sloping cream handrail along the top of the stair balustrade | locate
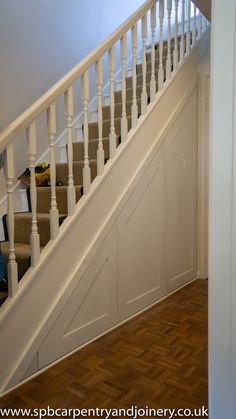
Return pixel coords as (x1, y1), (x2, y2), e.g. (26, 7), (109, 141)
(0, 0), (158, 151)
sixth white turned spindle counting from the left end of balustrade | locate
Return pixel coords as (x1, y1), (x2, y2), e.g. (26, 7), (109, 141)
(96, 58), (104, 175)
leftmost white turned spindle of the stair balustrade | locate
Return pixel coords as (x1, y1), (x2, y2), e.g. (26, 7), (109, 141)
(6, 143), (18, 297)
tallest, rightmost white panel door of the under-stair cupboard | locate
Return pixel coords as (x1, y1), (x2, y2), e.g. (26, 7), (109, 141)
(165, 90), (197, 292)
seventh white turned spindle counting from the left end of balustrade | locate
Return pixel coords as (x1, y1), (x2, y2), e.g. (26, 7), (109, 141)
(109, 45), (116, 158)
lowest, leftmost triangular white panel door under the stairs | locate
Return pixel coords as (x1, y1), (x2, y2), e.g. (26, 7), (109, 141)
(39, 228), (118, 368)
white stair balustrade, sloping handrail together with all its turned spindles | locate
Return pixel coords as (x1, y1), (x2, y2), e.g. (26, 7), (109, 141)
(0, 0), (207, 304)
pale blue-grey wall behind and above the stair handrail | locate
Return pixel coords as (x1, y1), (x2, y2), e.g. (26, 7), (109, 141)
(0, 0), (144, 202)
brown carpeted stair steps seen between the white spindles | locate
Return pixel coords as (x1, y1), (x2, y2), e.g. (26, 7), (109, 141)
(1, 42), (171, 301)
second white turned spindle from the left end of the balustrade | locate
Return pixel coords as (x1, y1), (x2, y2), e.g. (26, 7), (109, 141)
(27, 122), (40, 266)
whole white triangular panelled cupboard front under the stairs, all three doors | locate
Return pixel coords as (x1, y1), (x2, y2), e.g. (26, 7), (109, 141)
(39, 89), (197, 368)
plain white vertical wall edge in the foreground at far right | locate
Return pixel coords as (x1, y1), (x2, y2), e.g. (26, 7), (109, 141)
(209, 0), (236, 419)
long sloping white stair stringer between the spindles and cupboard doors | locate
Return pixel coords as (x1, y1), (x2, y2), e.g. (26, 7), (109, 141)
(0, 30), (210, 394)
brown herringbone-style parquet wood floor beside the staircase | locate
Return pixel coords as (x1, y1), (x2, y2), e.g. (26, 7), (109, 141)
(0, 280), (208, 416)
